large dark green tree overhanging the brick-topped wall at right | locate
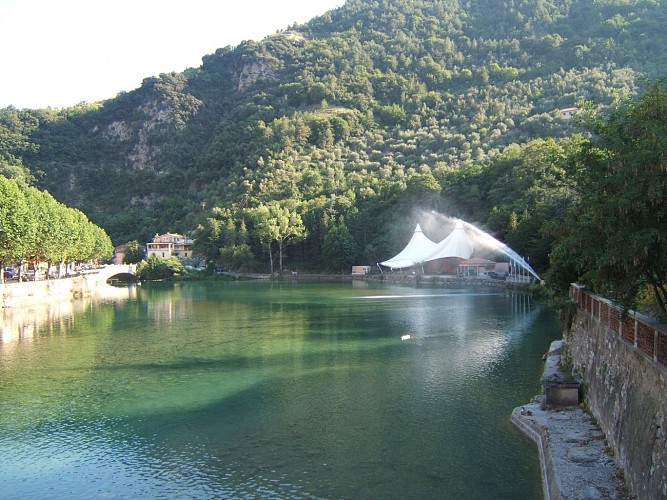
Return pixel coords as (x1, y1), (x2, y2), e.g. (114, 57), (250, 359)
(552, 83), (667, 315)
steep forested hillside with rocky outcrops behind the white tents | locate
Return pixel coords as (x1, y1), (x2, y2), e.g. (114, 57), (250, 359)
(0, 0), (667, 278)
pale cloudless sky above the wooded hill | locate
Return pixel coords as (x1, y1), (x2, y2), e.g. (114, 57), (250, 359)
(0, 0), (344, 108)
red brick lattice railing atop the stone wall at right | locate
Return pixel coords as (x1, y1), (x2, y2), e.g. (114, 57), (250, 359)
(570, 284), (667, 368)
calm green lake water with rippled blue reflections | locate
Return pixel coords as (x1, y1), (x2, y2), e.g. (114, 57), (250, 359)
(0, 281), (560, 499)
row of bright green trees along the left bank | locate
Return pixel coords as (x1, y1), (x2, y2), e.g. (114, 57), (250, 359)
(0, 176), (113, 279)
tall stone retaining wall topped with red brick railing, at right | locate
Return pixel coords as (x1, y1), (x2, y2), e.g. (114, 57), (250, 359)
(565, 286), (667, 499)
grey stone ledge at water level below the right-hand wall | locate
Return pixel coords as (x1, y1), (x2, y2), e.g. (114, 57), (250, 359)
(511, 341), (634, 500)
